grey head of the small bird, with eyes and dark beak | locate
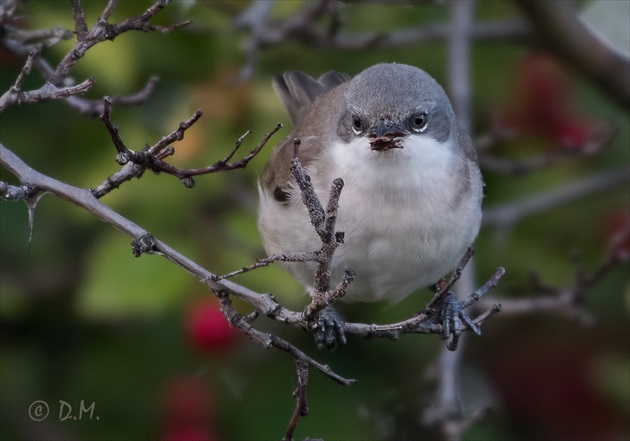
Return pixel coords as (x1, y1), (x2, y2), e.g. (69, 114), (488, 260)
(338, 64), (457, 151)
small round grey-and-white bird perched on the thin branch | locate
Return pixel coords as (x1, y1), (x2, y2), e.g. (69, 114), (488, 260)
(258, 63), (484, 345)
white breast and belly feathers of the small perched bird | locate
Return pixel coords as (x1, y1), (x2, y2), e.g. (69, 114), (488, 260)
(259, 136), (481, 301)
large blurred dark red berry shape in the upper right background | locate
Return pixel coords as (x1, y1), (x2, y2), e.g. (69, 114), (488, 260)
(497, 53), (597, 149)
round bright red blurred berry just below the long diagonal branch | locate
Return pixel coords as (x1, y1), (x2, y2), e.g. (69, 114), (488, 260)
(186, 298), (235, 353)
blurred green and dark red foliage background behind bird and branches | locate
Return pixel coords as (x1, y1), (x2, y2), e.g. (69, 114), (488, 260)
(0, 0), (630, 441)
